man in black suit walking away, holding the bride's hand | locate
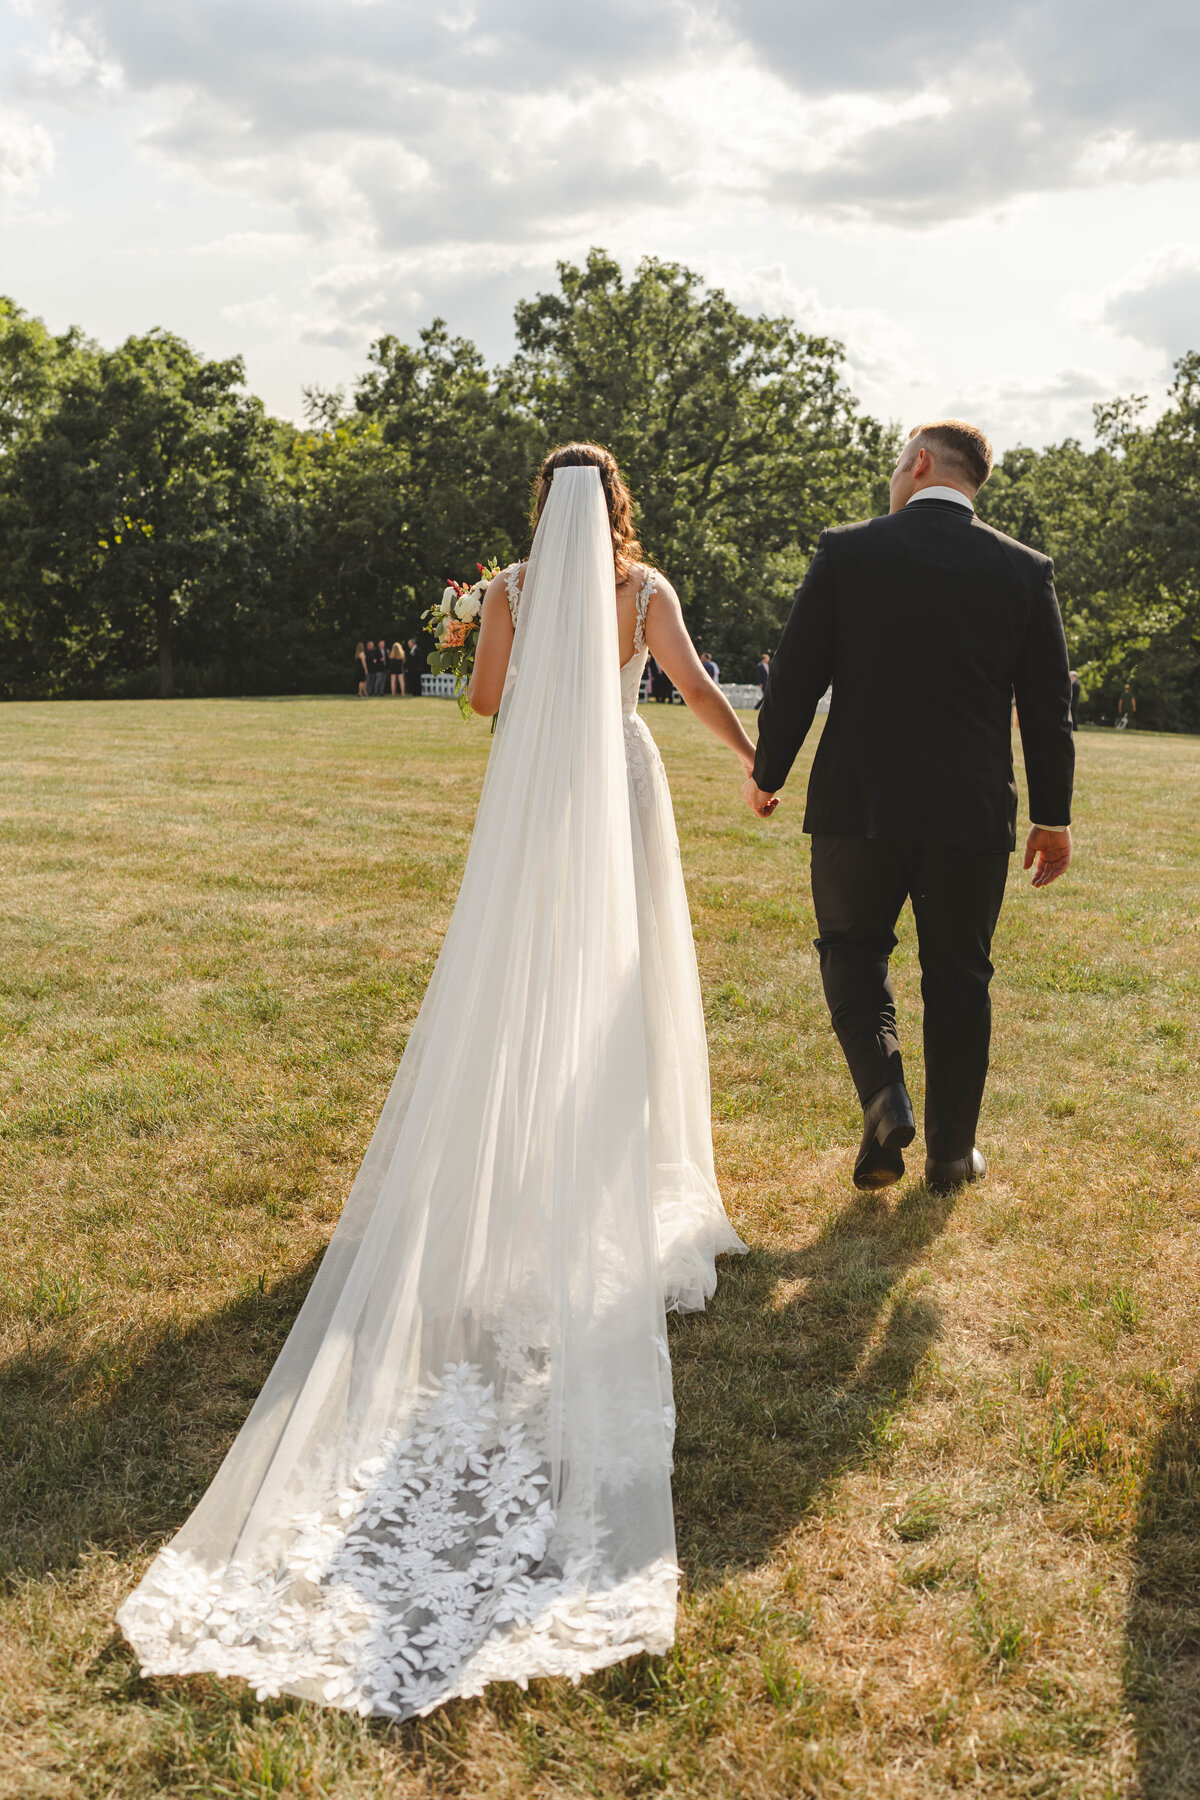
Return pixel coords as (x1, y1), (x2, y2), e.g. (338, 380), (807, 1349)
(745, 419), (1074, 1192)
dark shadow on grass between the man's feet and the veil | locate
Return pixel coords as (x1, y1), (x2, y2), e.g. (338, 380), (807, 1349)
(671, 1186), (954, 1586)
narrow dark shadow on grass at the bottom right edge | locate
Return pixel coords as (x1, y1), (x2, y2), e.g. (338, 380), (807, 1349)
(1124, 1382), (1200, 1800)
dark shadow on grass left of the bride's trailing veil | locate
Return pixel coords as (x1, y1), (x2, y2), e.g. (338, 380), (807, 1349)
(0, 1256), (320, 1580)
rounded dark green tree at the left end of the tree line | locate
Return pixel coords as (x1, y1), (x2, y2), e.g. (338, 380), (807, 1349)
(0, 331), (279, 695)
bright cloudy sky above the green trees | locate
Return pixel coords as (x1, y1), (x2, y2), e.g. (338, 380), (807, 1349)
(0, 0), (1200, 445)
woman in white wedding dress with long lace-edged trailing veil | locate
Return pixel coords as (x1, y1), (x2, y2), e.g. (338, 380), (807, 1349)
(117, 445), (754, 1719)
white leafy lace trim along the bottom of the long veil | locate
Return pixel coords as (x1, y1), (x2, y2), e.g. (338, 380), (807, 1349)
(119, 1346), (676, 1719)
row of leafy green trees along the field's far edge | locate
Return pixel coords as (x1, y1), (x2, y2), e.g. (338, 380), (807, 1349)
(0, 250), (1200, 729)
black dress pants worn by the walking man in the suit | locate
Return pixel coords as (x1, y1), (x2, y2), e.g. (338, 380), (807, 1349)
(811, 835), (1009, 1161)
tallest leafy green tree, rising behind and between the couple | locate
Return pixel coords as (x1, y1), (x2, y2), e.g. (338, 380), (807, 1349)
(506, 250), (891, 671)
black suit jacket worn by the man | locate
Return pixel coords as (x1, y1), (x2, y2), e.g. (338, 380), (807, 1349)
(754, 500), (1074, 850)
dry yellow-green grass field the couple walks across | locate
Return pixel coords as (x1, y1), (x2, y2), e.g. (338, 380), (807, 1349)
(0, 700), (1200, 1800)
